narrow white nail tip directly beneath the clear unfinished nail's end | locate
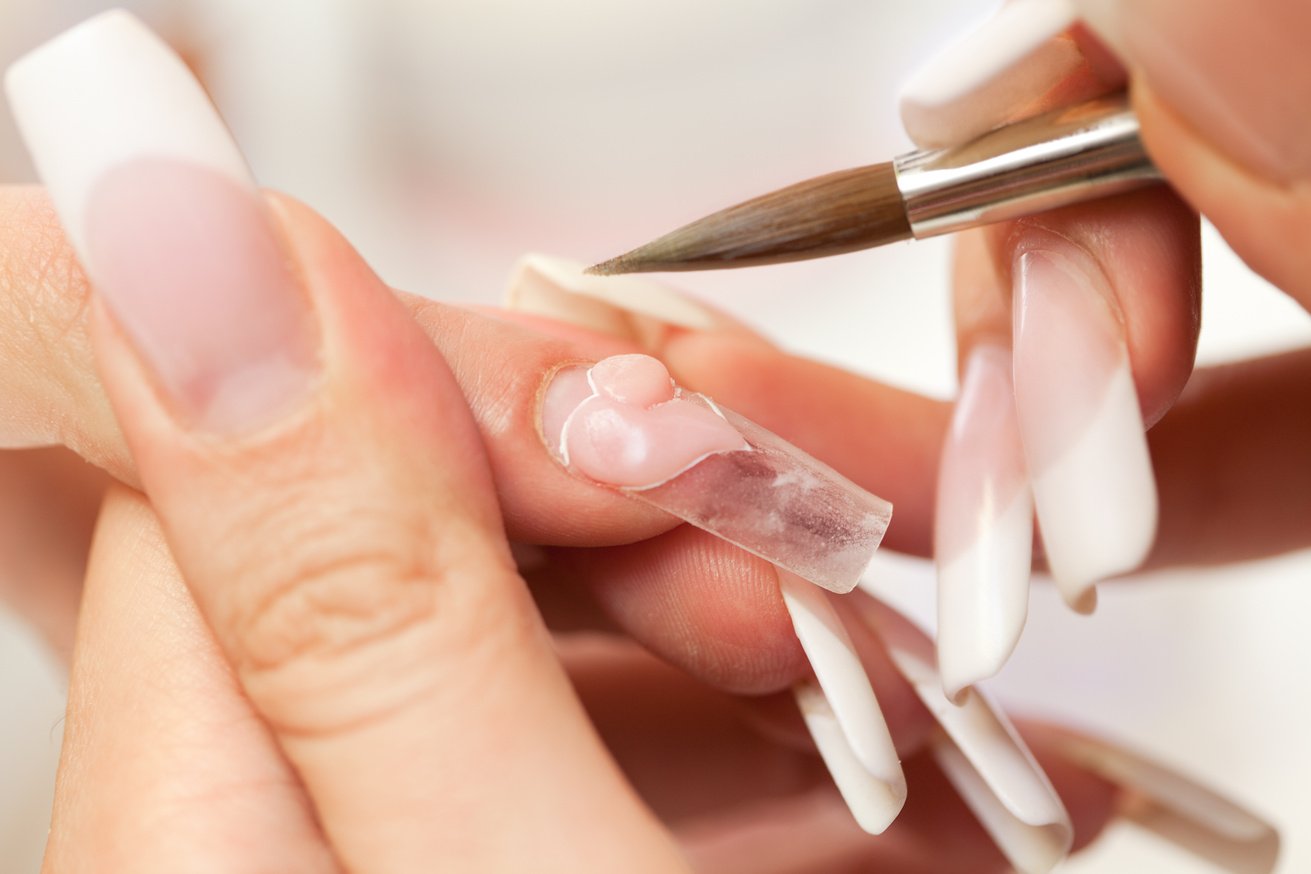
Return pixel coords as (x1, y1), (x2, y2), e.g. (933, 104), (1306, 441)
(777, 569), (905, 785)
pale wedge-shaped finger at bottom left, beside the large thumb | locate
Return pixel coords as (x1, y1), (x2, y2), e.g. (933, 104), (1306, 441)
(43, 487), (338, 874)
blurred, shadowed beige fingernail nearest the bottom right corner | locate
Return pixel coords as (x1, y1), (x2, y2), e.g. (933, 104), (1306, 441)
(1054, 731), (1280, 874)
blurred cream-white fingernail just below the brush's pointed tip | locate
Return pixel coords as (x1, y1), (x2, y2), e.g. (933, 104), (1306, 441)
(503, 254), (758, 349)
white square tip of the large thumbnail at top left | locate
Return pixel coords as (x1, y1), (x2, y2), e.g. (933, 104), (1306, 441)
(5, 9), (249, 259)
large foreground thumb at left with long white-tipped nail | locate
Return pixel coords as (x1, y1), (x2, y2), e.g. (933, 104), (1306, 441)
(9, 13), (679, 871)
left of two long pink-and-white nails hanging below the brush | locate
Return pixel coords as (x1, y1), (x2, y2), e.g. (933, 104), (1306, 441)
(933, 345), (1033, 700)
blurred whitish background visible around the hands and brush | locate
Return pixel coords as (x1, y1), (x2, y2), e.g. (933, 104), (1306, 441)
(0, 0), (1311, 874)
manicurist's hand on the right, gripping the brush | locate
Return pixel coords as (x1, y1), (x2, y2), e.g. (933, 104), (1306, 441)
(880, 0), (1311, 689)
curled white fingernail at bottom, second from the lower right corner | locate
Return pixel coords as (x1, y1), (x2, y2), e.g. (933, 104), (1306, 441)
(853, 596), (1074, 874)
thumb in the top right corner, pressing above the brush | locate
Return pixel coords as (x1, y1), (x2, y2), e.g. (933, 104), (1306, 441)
(1076, 0), (1311, 308)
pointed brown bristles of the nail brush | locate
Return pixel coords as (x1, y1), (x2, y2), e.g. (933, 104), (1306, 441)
(587, 164), (911, 275)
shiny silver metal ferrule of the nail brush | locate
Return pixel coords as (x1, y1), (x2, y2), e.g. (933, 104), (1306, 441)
(894, 94), (1162, 237)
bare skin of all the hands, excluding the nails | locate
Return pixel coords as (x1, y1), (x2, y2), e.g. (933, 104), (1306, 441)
(0, 4), (1311, 873)
